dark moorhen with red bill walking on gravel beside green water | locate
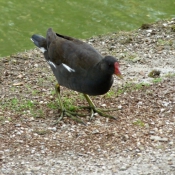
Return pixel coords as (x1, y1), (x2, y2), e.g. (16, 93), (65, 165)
(31, 28), (122, 123)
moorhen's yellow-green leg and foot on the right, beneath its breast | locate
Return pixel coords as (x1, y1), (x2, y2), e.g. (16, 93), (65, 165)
(83, 94), (116, 119)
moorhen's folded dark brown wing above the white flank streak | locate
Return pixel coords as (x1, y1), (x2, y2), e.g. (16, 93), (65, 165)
(46, 29), (103, 70)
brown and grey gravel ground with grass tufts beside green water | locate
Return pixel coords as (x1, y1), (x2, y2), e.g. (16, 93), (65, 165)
(0, 19), (175, 175)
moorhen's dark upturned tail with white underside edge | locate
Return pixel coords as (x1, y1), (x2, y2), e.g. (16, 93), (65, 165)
(31, 34), (47, 52)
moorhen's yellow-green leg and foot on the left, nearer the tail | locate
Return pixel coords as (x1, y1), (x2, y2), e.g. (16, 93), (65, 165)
(55, 84), (85, 125)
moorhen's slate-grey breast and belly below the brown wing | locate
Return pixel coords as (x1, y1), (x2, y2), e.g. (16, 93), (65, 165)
(52, 64), (113, 95)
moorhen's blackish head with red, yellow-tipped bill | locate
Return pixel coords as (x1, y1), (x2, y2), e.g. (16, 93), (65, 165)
(101, 56), (123, 79)
